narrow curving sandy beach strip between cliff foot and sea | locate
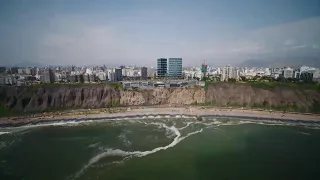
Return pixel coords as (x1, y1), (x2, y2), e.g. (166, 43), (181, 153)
(0, 106), (320, 128)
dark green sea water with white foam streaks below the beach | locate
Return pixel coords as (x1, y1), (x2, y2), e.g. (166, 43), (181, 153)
(0, 118), (320, 180)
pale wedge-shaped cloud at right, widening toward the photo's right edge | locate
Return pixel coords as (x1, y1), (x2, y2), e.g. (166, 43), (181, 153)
(203, 17), (320, 62)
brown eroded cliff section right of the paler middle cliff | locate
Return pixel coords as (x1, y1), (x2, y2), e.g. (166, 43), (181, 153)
(206, 83), (320, 110)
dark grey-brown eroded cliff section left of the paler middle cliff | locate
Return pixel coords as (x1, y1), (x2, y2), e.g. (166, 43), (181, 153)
(0, 85), (120, 112)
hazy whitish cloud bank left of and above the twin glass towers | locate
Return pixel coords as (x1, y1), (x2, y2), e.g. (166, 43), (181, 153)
(37, 16), (205, 65)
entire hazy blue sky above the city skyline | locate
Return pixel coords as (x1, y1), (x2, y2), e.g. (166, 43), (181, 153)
(0, 0), (320, 66)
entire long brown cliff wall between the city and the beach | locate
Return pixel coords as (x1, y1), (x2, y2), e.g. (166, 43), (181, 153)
(0, 83), (320, 114)
